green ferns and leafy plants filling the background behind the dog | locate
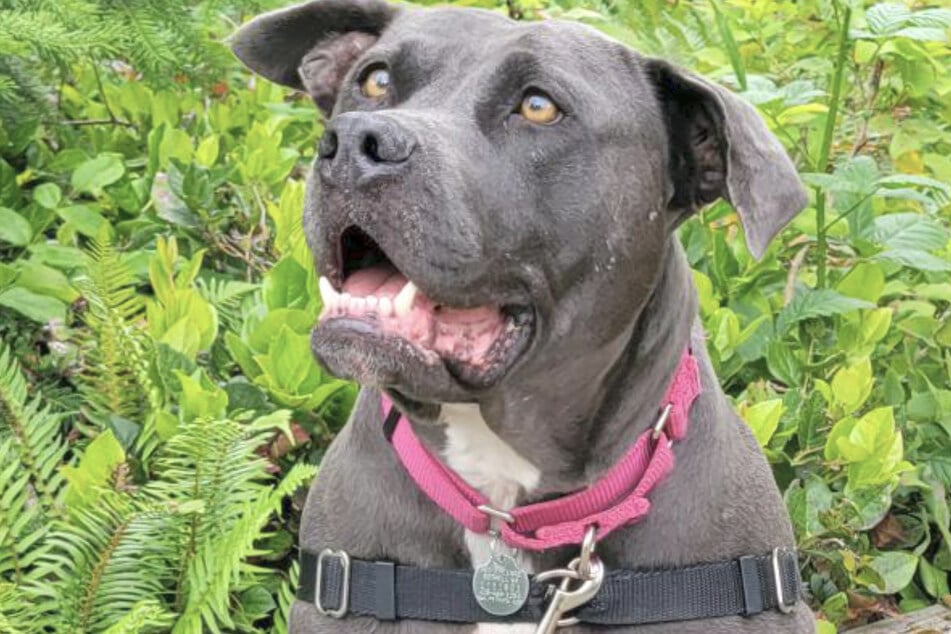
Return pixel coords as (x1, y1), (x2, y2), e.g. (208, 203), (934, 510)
(0, 0), (951, 633)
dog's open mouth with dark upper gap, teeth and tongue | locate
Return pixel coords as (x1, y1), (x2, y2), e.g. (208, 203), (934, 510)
(320, 226), (533, 387)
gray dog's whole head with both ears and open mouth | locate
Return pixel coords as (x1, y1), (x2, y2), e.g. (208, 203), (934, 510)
(233, 0), (805, 402)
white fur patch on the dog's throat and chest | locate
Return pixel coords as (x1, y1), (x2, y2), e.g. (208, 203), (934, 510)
(439, 403), (541, 634)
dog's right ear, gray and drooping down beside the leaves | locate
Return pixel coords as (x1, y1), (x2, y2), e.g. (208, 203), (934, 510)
(646, 60), (807, 258)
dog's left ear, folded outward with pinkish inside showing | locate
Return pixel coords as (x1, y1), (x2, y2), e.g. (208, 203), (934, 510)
(230, 0), (397, 114)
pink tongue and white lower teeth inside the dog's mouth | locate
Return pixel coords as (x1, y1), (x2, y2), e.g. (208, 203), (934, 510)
(320, 265), (506, 367)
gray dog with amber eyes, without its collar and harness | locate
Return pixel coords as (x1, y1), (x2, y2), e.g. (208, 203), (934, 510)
(232, 0), (815, 634)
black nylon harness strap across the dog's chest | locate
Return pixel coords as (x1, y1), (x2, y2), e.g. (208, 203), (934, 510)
(297, 549), (801, 625)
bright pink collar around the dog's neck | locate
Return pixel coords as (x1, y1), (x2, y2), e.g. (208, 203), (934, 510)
(383, 348), (701, 550)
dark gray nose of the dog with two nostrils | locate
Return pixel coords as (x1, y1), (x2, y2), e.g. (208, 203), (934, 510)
(317, 112), (416, 181)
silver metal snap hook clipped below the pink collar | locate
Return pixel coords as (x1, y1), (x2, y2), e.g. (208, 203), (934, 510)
(535, 526), (604, 634)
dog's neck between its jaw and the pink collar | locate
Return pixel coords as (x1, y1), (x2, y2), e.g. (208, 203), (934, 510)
(416, 238), (697, 506)
